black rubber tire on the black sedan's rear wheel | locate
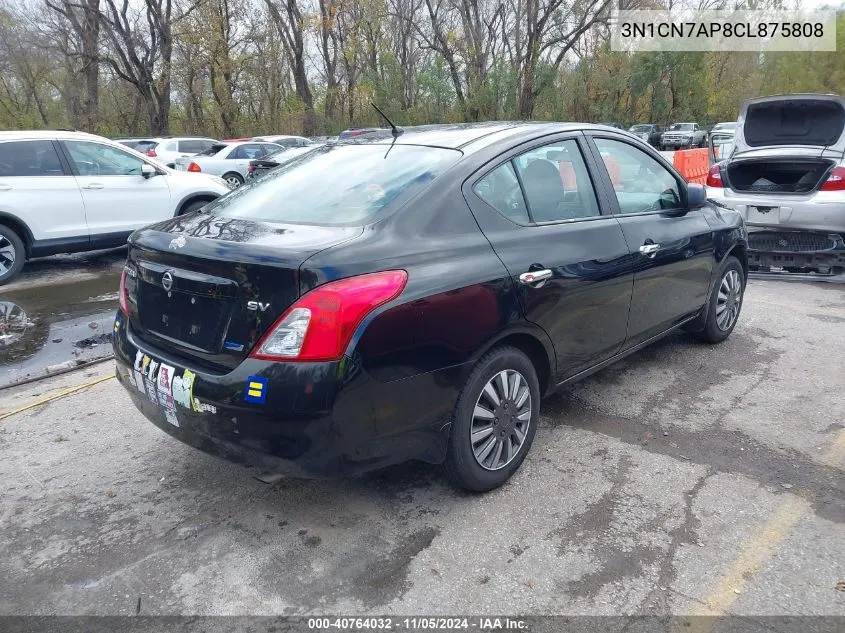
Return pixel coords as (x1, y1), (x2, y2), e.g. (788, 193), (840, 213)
(443, 346), (540, 492)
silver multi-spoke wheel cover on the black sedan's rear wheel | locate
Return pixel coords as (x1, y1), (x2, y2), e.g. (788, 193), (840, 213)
(470, 369), (531, 470)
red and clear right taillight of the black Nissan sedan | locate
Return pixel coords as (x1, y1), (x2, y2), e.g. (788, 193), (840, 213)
(250, 270), (408, 361)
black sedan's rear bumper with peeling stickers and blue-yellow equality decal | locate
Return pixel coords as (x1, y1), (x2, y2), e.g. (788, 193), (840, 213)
(114, 314), (460, 478)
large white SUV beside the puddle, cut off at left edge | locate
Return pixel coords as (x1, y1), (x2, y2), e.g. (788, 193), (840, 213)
(0, 131), (229, 285)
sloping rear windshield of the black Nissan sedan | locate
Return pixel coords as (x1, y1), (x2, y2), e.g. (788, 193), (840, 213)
(205, 144), (461, 225)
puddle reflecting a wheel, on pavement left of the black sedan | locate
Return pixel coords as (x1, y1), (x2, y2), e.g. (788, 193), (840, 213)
(0, 271), (120, 387)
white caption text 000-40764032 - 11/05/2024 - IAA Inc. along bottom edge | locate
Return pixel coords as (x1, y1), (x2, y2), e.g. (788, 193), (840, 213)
(308, 616), (528, 631)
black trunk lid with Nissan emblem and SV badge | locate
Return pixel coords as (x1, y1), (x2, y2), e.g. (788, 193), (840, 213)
(127, 214), (363, 371)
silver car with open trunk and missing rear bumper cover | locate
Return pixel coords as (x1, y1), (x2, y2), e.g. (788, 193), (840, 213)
(707, 94), (845, 275)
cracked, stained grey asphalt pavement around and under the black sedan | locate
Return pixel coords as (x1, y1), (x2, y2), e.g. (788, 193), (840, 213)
(0, 270), (845, 616)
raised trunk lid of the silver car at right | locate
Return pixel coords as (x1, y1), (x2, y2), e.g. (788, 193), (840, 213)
(734, 95), (845, 157)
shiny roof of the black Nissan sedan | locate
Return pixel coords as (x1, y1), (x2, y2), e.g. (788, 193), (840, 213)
(336, 121), (620, 153)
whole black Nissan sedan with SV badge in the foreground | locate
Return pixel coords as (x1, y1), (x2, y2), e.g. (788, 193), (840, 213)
(114, 123), (747, 491)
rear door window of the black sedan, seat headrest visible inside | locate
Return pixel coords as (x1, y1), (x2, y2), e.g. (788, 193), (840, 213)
(513, 140), (600, 222)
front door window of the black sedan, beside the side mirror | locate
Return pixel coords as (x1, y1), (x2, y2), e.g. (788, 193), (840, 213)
(595, 138), (682, 213)
